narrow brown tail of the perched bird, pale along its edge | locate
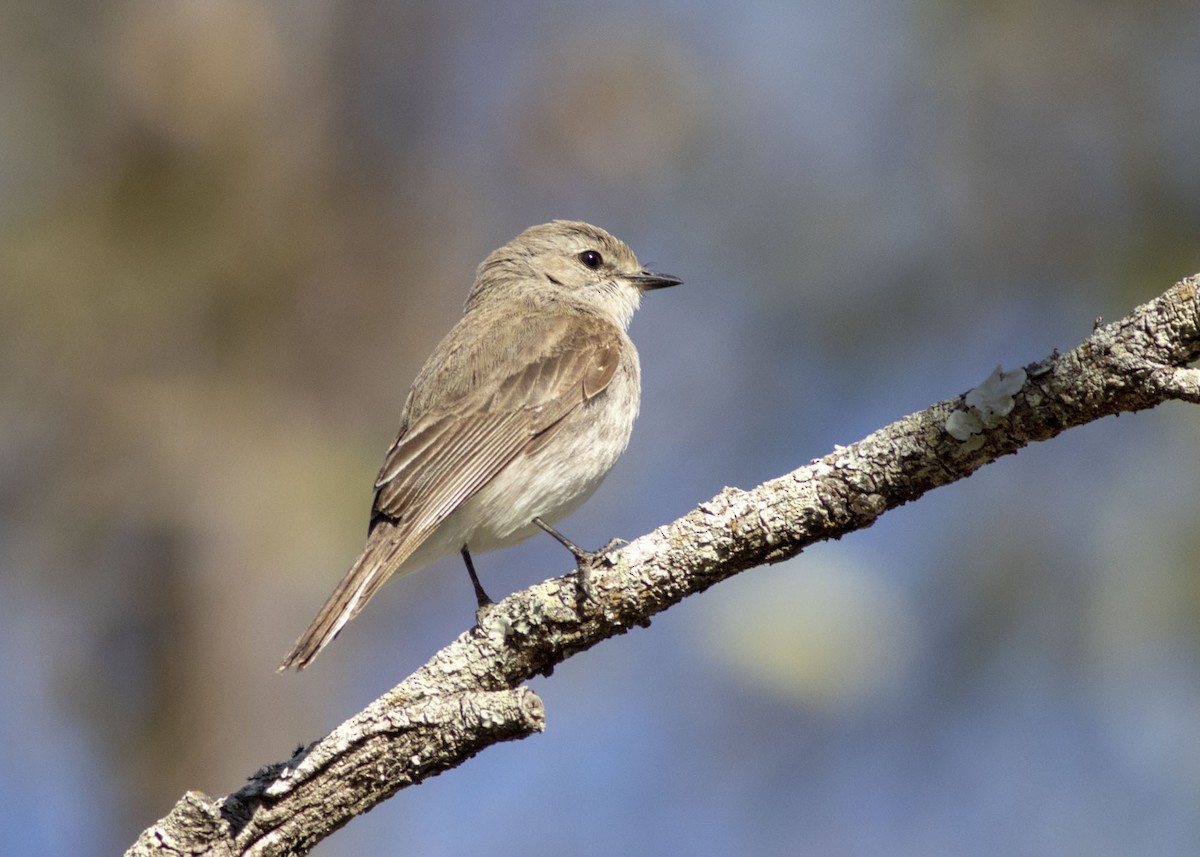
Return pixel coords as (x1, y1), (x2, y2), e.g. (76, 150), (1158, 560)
(278, 523), (416, 672)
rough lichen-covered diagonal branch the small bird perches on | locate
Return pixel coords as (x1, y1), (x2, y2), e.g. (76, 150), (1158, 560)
(126, 275), (1200, 857)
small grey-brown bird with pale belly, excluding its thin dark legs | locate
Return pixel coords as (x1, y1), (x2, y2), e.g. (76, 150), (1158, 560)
(280, 221), (679, 670)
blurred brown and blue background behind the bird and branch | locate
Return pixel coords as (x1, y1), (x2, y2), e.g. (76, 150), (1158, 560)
(0, 0), (1200, 857)
